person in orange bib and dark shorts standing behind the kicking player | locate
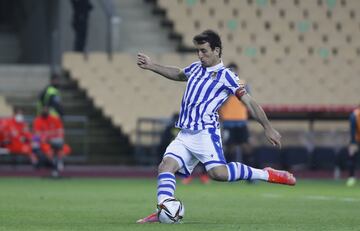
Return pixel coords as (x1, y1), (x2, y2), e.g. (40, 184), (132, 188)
(219, 63), (253, 172)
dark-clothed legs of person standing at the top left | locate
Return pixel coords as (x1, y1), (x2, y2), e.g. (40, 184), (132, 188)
(71, 0), (93, 52)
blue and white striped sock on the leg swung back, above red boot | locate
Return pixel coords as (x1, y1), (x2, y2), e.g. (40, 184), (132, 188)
(226, 162), (269, 181)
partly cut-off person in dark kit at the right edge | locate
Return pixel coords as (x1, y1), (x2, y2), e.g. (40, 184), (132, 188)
(346, 105), (360, 187)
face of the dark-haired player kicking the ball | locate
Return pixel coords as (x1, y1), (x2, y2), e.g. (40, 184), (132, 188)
(195, 43), (220, 67)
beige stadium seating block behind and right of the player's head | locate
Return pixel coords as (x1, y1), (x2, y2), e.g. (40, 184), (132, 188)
(158, 0), (360, 105)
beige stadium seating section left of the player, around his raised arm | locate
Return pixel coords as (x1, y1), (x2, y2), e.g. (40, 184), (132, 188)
(63, 53), (195, 141)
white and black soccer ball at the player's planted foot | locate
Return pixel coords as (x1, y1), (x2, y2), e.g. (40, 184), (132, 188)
(157, 198), (185, 224)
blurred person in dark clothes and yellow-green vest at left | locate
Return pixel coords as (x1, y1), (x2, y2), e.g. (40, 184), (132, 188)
(37, 74), (64, 118)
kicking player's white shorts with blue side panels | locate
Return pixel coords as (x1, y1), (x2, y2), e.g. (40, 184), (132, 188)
(164, 128), (226, 176)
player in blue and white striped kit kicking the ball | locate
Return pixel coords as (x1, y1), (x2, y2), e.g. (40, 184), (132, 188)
(137, 30), (296, 223)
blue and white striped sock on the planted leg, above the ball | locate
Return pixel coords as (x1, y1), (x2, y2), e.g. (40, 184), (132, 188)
(157, 172), (176, 204)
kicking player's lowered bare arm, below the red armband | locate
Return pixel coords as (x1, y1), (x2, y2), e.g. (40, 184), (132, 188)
(238, 93), (281, 148)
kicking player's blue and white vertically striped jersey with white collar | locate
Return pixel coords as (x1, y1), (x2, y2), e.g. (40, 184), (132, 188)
(175, 61), (245, 130)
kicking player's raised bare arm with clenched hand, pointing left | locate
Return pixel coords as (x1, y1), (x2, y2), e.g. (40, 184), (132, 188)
(137, 53), (187, 81)
